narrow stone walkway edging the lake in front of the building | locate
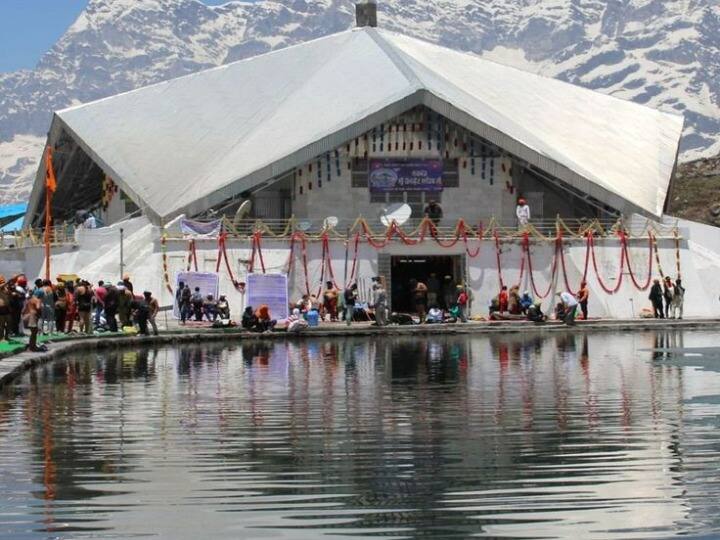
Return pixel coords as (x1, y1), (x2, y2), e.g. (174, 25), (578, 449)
(0, 319), (720, 386)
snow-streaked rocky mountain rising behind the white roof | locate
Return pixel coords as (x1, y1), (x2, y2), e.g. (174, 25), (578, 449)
(0, 0), (720, 202)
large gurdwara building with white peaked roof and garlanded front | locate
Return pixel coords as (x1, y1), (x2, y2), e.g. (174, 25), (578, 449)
(3, 3), (720, 317)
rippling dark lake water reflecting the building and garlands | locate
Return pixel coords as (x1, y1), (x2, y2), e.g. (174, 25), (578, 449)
(0, 332), (720, 538)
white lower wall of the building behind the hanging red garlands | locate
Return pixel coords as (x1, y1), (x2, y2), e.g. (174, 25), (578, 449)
(0, 222), (720, 318)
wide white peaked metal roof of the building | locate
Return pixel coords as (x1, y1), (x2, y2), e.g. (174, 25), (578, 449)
(28, 27), (683, 221)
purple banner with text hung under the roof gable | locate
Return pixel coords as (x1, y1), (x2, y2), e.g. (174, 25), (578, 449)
(368, 159), (443, 193)
